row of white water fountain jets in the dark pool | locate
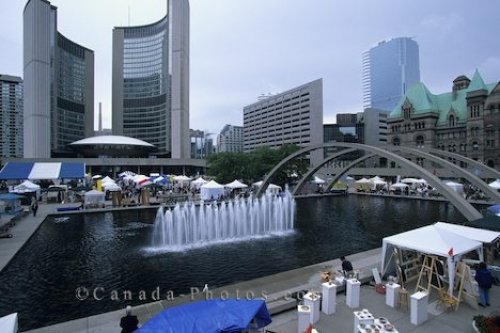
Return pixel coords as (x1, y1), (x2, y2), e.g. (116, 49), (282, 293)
(153, 190), (295, 250)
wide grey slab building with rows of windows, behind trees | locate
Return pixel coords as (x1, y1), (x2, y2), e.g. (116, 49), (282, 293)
(243, 79), (323, 164)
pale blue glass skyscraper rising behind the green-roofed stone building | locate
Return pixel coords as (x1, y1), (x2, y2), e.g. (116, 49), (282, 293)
(363, 37), (420, 111)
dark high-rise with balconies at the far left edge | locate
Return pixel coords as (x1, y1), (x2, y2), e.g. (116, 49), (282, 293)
(0, 74), (23, 157)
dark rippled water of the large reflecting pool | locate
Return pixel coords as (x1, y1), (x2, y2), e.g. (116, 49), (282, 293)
(0, 195), (465, 331)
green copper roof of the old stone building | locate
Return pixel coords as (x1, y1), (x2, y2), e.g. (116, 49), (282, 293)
(389, 70), (497, 126)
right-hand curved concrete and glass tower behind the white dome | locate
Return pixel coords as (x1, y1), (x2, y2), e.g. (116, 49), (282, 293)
(112, 0), (190, 158)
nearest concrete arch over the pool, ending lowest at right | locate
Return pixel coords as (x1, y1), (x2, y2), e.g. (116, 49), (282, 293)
(257, 142), (482, 221)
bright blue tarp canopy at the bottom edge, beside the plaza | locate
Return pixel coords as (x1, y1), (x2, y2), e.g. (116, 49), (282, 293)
(135, 299), (271, 333)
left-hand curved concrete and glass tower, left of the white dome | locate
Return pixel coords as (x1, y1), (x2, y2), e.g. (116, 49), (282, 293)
(23, 0), (94, 158)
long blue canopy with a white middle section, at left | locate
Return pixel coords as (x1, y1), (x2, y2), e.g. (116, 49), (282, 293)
(0, 162), (85, 180)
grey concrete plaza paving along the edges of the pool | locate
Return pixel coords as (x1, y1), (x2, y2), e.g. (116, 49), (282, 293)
(0, 204), (500, 333)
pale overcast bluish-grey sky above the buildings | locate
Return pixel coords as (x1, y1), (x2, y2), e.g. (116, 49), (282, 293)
(0, 0), (500, 133)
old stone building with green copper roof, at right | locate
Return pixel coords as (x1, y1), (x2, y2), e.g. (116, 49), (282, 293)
(387, 71), (500, 170)
